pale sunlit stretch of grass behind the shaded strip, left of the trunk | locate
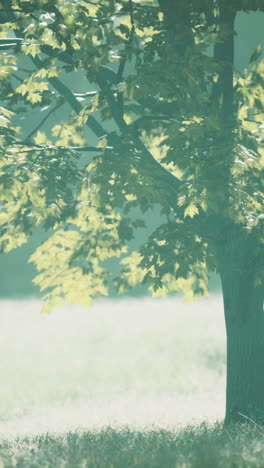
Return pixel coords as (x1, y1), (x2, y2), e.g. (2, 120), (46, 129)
(0, 296), (225, 436)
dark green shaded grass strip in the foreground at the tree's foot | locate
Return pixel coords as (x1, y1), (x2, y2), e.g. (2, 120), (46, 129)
(0, 424), (264, 468)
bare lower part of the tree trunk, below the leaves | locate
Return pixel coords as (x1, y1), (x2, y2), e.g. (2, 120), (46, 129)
(221, 241), (264, 423)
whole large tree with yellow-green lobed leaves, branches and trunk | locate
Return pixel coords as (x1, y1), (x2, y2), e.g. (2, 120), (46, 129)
(0, 0), (264, 422)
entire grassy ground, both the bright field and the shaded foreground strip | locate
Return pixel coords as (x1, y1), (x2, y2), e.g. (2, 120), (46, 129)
(0, 295), (264, 468)
